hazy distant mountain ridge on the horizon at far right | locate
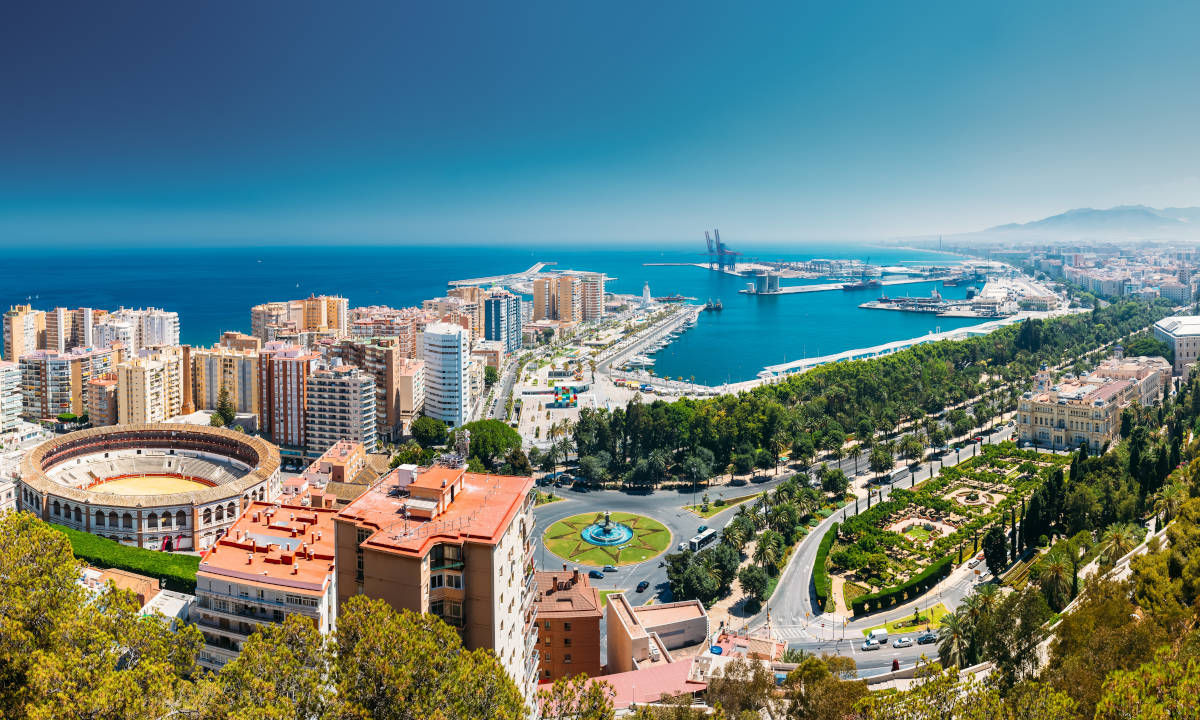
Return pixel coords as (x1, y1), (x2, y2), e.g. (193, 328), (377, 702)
(984, 205), (1200, 236)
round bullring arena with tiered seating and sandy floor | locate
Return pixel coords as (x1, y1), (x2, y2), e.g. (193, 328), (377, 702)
(18, 424), (280, 551)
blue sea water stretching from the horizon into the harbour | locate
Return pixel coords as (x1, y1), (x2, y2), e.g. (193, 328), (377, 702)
(0, 245), (977, 384)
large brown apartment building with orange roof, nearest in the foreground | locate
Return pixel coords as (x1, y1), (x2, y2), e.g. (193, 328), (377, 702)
(335, 463), (539, 697)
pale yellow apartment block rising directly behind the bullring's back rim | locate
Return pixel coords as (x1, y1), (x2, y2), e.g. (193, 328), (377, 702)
(116, 347), (184, 425)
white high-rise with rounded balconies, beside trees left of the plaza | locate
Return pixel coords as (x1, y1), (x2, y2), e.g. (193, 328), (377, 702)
(420, 323), (470, 427)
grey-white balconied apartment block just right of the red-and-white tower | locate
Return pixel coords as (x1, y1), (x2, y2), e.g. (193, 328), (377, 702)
(305, 365), (378, 457)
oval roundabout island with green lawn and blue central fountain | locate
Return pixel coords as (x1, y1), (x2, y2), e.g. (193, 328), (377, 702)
(542, 511), (671, 568)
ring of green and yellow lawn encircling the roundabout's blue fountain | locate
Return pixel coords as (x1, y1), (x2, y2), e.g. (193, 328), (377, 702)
(545, 512), (671, 568)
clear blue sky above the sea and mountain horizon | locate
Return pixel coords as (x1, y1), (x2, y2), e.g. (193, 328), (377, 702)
(0, 0), (1200, 247)
